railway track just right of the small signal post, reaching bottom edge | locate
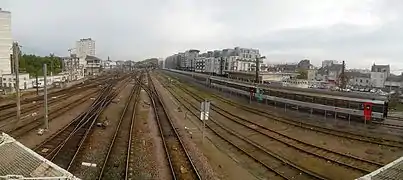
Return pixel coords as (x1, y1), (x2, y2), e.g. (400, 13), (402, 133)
(161, 75), (326, 179)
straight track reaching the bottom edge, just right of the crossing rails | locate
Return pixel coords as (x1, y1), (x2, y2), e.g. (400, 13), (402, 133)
(98, 75), (142, 179)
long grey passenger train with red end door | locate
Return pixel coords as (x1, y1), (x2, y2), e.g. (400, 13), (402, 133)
(166, 69), (388, 121)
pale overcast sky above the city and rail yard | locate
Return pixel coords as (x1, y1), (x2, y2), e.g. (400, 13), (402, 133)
(0, 0), (403, 72)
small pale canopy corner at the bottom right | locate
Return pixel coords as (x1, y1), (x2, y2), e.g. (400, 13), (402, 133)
(357, 157), (403, 180)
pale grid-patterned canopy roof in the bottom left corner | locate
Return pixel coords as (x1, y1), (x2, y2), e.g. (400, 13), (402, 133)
(0, 133), (79, 180)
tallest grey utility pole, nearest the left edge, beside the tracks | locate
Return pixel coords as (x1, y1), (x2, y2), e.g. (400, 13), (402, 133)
(13, 42), (21, 128)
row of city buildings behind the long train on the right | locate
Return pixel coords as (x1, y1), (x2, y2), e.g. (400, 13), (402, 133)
(163, 47), (403, 91)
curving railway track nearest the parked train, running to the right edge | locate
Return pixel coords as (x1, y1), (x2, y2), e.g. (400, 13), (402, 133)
(164, 74), (403, 148)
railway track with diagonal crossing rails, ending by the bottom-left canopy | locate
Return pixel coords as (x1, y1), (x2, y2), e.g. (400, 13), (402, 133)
(34, 82), (117, 170)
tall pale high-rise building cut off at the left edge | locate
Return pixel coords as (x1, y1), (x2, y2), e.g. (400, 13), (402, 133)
(0, 8), (13, 76)
